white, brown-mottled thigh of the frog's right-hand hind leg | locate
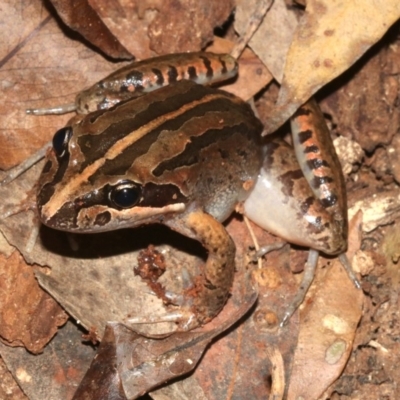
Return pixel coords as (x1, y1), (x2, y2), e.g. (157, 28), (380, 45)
(244, 150), (343, 254)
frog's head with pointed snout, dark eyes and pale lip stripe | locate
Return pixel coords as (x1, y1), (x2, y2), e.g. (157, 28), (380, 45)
(37, 119), (186, 233)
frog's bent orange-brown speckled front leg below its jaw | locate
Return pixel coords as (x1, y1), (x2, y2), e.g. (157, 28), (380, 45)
(165, 210), (236, 330)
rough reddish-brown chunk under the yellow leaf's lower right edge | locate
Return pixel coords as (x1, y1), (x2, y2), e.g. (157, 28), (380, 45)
(324, 39), (400, 153)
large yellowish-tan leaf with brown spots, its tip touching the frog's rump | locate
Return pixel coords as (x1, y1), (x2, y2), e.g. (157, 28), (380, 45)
(266, 0), (400, 132)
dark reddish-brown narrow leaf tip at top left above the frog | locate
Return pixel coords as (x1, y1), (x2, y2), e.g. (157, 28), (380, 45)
(51, 0), (133, 60)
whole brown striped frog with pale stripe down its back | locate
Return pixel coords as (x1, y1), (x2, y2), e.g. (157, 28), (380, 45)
(22, 53), (355, 329)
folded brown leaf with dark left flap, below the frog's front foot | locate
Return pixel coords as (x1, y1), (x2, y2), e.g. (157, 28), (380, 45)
(74, 292), (257, 399)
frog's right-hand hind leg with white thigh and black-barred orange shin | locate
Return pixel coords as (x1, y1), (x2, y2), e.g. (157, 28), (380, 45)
(244, 96), (360, 324)
